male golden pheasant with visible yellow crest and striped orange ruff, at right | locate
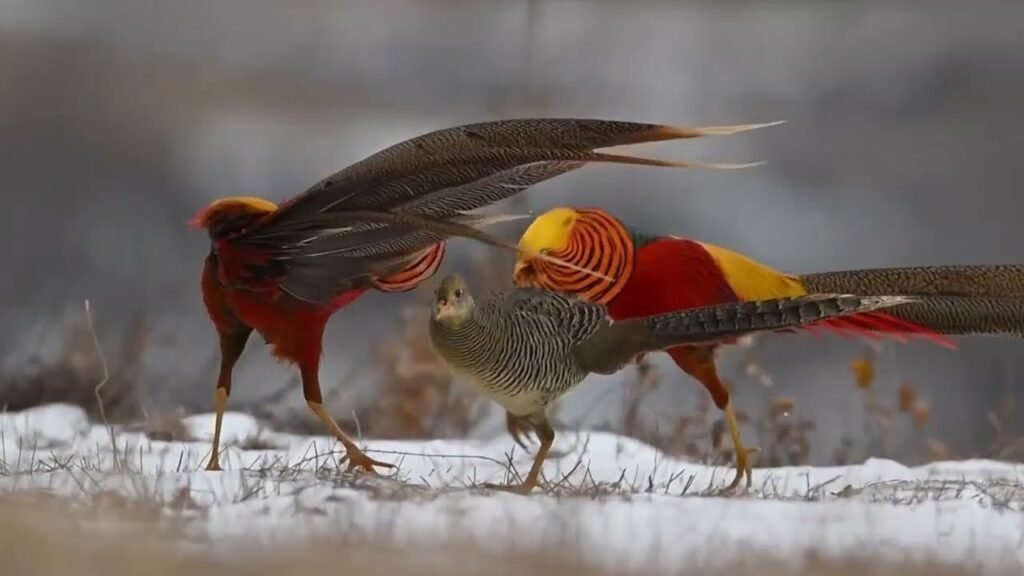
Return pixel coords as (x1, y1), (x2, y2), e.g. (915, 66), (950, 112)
(509, 207), (1024, 489)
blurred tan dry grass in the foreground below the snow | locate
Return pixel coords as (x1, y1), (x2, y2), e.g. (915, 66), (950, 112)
(0, 493), (1013, 576)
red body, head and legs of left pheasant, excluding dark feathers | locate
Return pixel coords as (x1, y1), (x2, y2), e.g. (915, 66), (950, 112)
(193, 198), (444, 470)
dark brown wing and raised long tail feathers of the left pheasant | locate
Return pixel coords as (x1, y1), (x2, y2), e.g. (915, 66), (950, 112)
(233, 119), (773, 300)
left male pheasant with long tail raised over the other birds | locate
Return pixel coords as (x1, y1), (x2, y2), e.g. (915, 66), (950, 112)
(191, 118), (769, 471)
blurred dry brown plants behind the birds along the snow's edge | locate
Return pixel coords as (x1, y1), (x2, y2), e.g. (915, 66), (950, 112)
(0, 252), (1024, 466)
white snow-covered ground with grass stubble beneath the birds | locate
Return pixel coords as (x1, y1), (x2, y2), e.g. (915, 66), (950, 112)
(0, 405), (1024, 570)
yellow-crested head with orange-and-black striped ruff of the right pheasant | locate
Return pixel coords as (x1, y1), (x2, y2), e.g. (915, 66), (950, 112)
(512, 207), (634, 303)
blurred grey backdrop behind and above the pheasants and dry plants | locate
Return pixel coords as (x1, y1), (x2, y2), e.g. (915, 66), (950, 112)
(0, 0), (1024, 458)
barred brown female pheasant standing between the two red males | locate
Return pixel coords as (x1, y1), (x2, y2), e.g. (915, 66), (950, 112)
(430, 274), (915, 493)
